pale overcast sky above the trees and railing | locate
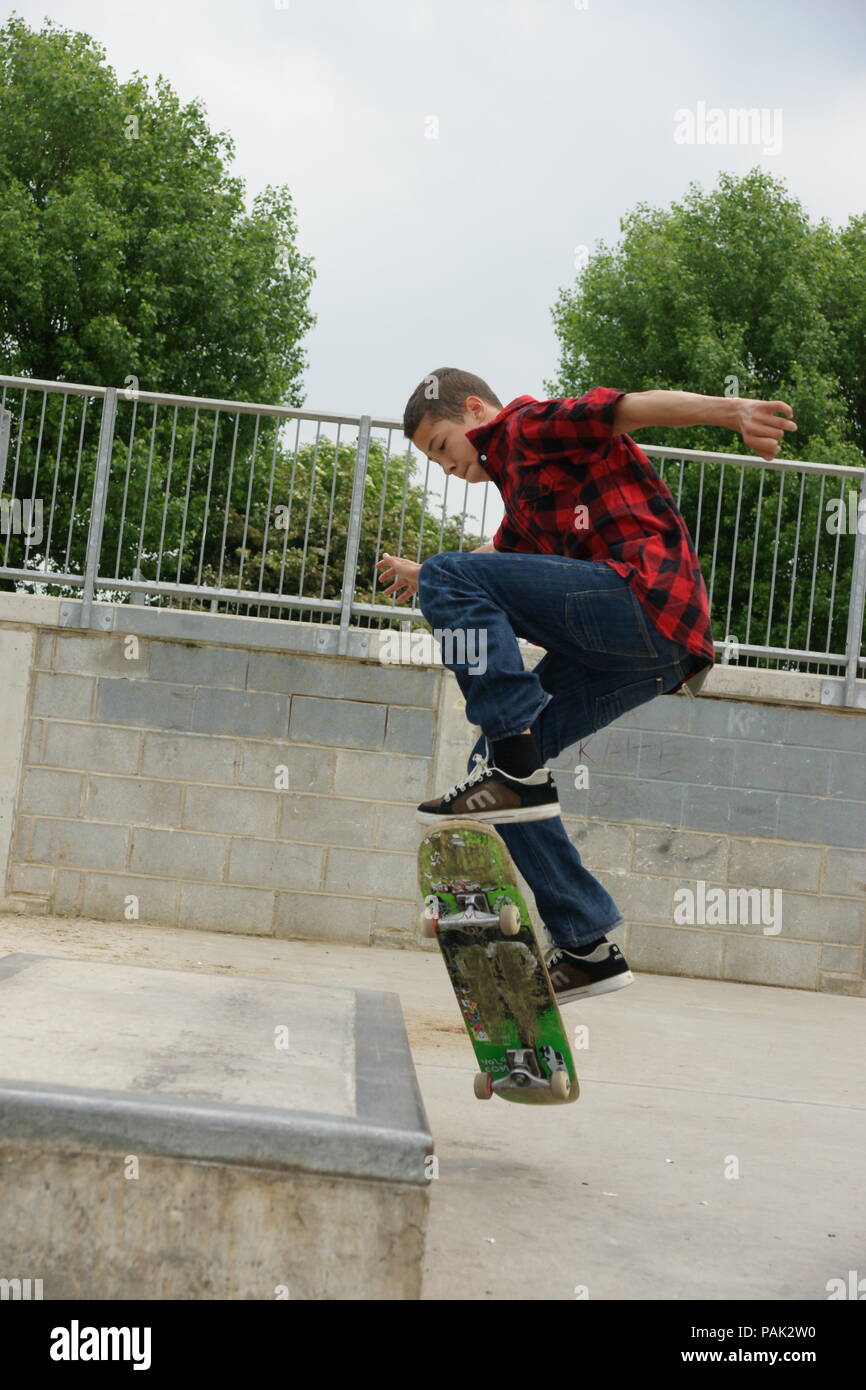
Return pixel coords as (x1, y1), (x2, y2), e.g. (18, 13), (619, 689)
(15, 0), (866, 417)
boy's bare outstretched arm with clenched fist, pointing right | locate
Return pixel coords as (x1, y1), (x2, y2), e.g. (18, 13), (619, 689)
(613, 391), (796, 461)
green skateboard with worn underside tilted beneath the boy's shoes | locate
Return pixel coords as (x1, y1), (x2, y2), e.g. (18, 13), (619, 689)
(418, 819), (580, 1105)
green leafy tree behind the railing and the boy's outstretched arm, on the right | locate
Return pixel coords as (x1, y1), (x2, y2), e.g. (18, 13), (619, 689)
(545, 170), (866, 667)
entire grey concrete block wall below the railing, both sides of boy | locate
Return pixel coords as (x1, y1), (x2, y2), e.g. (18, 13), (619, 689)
(0, 595), (866, 995)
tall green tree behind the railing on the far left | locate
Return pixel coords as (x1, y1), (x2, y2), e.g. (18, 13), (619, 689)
(0, 17), (314, 582)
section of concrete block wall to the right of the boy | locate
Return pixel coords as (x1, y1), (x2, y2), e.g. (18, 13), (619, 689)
(550, 695), (866, 995)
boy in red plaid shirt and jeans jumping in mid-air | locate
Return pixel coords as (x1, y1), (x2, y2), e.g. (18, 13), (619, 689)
(377, 367), (796, 1004)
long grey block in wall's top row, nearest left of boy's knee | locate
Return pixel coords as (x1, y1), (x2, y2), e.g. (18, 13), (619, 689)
(247, 652), (441, 709)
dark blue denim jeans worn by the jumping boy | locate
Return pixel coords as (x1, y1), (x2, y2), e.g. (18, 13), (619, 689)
(418, 552), (702, 947)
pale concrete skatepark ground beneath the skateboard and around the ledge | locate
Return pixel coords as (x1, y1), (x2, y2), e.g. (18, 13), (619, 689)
(0, 916), (866, 1300)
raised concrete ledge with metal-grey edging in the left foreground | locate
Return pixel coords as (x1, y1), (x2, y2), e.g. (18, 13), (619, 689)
(0, 954), (432, 1300)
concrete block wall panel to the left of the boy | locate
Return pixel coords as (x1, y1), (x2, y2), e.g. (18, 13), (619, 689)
(8, 630), (442, 942)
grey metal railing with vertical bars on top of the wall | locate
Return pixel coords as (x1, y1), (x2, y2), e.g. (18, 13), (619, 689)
(0, 377), (866, 705)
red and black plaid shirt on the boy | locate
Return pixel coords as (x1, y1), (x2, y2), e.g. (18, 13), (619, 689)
(466, 386), (716, 689)
